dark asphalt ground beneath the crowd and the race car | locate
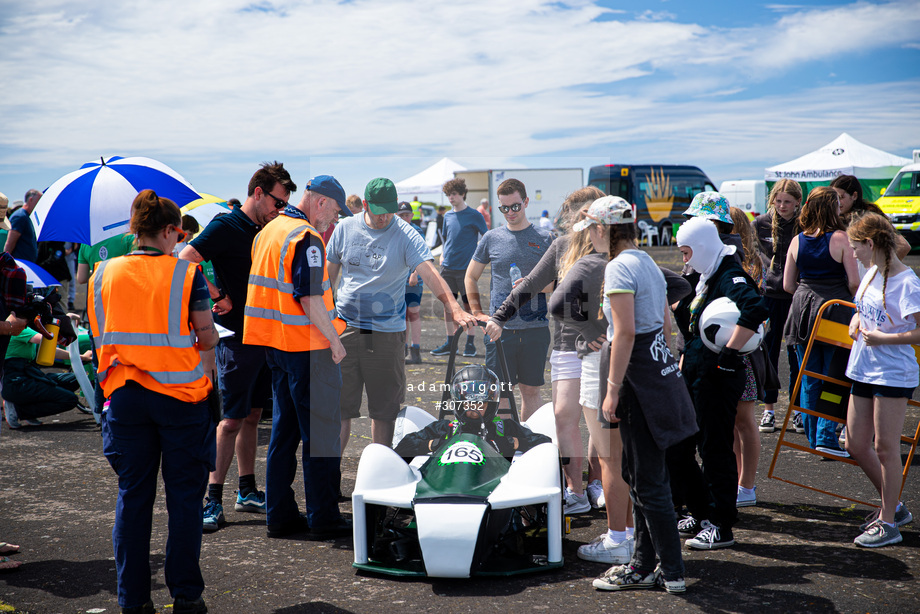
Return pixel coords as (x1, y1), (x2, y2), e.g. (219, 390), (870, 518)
(0, 247), (920, 614)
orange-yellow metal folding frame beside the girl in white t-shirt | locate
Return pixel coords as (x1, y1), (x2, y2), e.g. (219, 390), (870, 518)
(767, 300), (920, 507)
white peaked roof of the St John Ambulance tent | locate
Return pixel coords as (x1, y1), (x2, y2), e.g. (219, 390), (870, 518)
(764, 132), (910, 201)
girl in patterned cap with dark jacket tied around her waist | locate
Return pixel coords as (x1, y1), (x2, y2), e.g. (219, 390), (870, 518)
(589, 196), (697, 593)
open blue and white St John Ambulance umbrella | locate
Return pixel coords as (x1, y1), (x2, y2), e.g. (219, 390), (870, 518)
(30, 156), (201, 245)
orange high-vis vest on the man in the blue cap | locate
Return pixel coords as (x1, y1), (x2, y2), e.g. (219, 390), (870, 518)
(243, 215), (345, 352)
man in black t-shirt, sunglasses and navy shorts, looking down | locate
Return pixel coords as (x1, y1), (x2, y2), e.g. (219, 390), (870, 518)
(179, 162), (297, 532)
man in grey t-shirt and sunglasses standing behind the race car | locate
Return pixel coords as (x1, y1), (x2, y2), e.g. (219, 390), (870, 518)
(464, 179), (553, 420)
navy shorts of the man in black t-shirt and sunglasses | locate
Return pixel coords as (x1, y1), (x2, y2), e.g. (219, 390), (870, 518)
(214, 337), (272, 420)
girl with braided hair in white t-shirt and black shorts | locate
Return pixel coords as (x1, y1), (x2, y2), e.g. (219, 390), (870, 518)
(846, 213), (920, 548)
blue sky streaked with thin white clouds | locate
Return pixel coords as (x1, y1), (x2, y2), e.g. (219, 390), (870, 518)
(0, 0), (920, 207)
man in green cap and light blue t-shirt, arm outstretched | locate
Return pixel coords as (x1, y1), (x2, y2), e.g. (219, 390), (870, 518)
(326, 177), (476, 449)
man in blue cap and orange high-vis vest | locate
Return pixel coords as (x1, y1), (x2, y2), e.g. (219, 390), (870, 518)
(243, 175), (351, 539)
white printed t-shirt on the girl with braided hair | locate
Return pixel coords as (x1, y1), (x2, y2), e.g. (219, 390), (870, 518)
(846, 266), (920, 388)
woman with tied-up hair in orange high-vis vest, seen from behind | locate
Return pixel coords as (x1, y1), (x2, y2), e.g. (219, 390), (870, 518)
(87, 190), (217, 614)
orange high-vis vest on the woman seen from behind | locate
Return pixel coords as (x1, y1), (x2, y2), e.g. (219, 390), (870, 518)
(87, 255), (211, 403)
